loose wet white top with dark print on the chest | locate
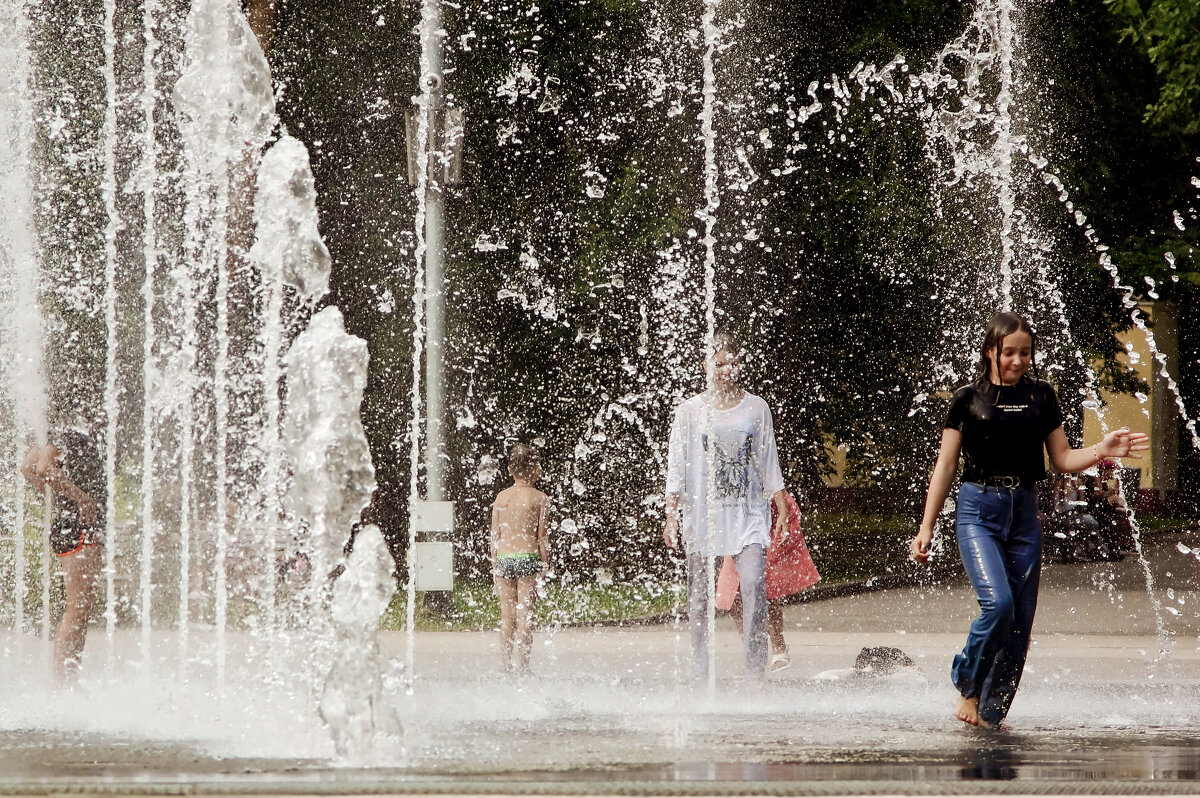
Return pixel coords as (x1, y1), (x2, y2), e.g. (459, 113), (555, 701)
(667, 394), (784, 556)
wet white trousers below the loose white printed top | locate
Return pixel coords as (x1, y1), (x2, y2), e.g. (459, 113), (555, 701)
(688, 544), (767, 679)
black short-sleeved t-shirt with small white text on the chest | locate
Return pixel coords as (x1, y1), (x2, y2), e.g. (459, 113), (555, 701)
(946, 377), (1062, 484)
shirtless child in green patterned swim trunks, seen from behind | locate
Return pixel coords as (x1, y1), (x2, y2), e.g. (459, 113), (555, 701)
(492, 444), (550, 673)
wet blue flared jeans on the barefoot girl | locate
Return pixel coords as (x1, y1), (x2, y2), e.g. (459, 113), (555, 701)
(950, 482), (1042, 724)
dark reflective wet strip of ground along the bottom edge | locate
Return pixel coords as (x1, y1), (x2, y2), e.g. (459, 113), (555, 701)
(7, 715), (1200, 794)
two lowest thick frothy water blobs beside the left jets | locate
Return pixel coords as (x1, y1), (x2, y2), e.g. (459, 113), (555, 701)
(283, 307), (376, 756)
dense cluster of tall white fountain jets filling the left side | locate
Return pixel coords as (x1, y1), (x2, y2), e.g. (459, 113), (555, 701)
(0, 0), (391, 758)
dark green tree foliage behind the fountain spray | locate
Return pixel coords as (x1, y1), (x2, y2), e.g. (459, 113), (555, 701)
(270, 0), (1200, 574)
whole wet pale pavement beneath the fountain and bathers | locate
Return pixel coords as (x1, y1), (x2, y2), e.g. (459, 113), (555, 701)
(7, 536), (1200, 794)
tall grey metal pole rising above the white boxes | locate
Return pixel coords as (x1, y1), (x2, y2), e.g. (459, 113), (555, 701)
(421, 0), (445, 502)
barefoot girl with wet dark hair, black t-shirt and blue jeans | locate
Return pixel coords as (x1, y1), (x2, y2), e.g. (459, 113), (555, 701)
(910, 312), (1148, 726)
